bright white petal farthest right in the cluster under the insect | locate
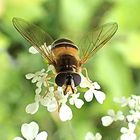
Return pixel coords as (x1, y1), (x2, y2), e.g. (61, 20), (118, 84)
(94, 90), (106, 104)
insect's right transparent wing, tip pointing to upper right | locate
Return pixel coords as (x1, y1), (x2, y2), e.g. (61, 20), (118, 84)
(79, 23), (118, 64)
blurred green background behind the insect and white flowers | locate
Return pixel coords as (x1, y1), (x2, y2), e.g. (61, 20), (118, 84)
(0, 0), (140, 140)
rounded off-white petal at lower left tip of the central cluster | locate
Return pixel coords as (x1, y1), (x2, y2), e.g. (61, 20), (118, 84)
(25, 102), (39, 114)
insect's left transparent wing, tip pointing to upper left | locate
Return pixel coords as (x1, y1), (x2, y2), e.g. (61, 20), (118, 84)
(12, 17), (55, 63)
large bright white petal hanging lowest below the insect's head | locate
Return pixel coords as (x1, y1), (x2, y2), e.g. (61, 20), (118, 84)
(59, 104), (72, 121)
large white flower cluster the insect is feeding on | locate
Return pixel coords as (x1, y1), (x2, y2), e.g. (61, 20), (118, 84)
(26, 65), (105, 121)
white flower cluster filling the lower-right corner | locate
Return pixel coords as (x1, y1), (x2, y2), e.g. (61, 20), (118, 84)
(101, 95), (140, 140)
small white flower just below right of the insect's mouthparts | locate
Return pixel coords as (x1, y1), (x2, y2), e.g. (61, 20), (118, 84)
(69, 93), (84, 108)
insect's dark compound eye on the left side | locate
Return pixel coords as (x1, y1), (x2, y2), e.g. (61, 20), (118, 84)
(55, 73), (67, 87)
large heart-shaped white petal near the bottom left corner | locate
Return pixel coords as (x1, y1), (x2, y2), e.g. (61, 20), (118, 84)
(21, 122), (39, 140)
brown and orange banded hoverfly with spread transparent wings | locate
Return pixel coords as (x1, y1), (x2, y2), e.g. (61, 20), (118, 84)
(12, 18), (118, 94)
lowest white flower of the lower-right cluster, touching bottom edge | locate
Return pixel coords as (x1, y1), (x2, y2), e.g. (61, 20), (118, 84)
(121, 123), (136, 140)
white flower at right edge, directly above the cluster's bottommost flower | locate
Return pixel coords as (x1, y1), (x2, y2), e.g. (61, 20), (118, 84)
(126, 110), (140, 122)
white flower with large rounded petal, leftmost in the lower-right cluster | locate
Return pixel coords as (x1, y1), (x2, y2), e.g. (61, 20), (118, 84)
(101, 109), (124, 126)
